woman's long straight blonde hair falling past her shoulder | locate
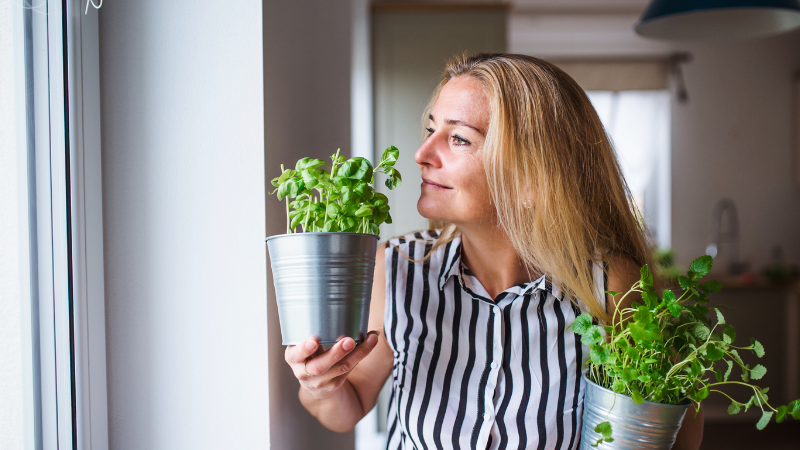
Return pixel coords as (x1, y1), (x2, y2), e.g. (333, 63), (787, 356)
(423, 54), (651, 322)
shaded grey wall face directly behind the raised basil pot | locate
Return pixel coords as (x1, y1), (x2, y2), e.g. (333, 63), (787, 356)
(264, 0), (354, 450)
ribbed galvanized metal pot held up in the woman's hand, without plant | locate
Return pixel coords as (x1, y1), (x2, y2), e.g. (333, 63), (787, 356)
(267, 233), (378, 345)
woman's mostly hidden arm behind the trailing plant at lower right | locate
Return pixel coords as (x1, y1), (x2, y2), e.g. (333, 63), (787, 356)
(606, 257), (704, 450)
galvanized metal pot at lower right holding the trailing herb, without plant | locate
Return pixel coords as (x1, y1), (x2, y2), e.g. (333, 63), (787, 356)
(581, 377), (690, 450)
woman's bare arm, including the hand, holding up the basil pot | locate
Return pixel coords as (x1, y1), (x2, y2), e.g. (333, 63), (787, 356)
(285, 246), (393, 432)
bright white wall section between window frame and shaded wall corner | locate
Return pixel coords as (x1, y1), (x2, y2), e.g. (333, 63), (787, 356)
(99, 0), (269, 450)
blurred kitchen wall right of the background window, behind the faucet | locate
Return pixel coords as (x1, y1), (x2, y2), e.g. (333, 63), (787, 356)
(672, 31), (800, 270)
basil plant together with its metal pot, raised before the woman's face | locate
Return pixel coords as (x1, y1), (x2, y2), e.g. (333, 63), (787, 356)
(267, 146), (401, 345)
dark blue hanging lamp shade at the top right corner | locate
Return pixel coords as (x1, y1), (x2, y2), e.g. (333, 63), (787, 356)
(634, 0), (800, 41)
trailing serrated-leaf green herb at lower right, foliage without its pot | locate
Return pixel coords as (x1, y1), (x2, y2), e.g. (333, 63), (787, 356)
(571, 256), (800, 447)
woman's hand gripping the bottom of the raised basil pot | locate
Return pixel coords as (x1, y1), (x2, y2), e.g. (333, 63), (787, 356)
(284, 330), (379, 399)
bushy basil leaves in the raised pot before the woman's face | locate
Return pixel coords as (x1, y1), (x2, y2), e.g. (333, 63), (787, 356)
(270, 146), (402, 234)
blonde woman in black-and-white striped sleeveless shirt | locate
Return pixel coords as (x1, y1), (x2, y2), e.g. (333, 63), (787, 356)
(286, 54), (702, 449)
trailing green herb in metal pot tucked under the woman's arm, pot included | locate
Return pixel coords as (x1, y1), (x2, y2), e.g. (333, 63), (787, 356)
(571, 256), (800, 449)
